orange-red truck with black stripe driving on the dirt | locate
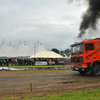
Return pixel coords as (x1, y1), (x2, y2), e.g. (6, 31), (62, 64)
(71, 38), (100, 76)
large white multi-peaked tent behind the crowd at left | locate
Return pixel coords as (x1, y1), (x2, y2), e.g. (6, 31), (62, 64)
(0, 40), (47, 58)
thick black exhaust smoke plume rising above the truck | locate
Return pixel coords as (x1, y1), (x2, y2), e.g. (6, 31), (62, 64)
(68, 0), (100, 38)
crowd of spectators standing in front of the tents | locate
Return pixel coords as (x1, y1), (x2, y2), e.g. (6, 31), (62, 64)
(0, 57), (62, 66)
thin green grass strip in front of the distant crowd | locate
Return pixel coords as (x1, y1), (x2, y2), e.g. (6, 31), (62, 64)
(1, 65), (71, 68)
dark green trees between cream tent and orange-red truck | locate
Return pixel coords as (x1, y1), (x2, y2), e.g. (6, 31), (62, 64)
(51, 48), (71, 57)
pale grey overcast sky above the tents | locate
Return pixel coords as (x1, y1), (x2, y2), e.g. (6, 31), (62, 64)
(0, 0), (99, 50)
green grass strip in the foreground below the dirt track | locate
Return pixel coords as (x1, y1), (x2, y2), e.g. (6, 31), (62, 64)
(2, 89), (100, 100)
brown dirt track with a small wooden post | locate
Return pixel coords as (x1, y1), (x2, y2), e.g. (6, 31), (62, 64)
(0, 70), (100, 98)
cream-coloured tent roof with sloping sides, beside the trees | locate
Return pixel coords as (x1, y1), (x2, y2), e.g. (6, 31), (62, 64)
(30, 51), (63, 58)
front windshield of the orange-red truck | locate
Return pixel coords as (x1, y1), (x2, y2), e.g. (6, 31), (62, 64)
(71, 43), (83, 55)
